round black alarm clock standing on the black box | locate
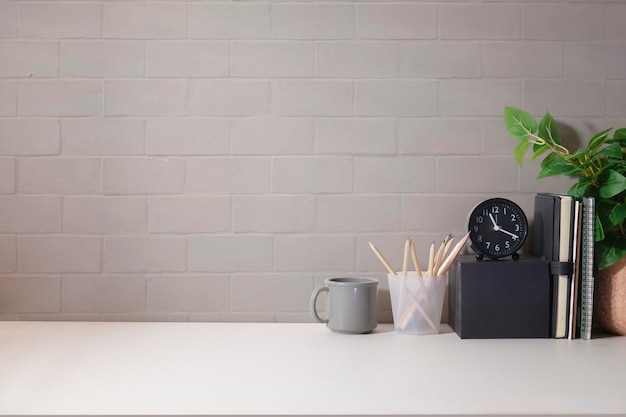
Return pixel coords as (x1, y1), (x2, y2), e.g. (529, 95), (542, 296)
(467, 198), (528, 261)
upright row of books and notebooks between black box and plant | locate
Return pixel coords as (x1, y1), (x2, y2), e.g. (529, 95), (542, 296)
(534, 193), (595, 339)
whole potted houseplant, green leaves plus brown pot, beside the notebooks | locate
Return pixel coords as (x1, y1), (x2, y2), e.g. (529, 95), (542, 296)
(504, 107), (626, 335)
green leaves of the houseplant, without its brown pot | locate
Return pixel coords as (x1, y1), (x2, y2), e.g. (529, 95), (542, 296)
(504, 107), (626, 269)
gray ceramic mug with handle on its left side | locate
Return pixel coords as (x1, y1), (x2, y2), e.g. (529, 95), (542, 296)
(309, 277), (378, 333)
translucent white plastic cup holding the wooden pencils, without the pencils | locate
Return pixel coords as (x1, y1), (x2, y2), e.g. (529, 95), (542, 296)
(387, 272), (448, 336)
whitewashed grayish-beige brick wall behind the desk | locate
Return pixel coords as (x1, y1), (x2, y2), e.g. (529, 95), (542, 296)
(0, 0), (626, 321)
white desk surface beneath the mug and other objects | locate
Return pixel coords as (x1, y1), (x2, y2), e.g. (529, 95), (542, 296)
(0, 322), (626, 416)
